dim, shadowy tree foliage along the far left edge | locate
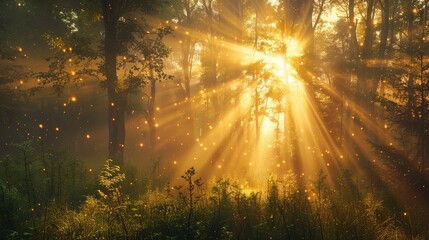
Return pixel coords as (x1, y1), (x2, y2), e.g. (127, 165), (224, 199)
(0, 0), (34, 150)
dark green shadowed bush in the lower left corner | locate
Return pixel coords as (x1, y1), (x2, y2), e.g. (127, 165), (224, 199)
(0, 141), (91, 239)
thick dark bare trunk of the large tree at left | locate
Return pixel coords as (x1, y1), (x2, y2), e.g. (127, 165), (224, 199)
(101, 0), (127, 165)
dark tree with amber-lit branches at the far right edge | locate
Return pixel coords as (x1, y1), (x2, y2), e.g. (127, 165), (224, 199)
(379, 1), (429, 172)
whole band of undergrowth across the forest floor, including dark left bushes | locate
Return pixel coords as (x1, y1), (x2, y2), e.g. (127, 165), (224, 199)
(0, 142), (429, 239)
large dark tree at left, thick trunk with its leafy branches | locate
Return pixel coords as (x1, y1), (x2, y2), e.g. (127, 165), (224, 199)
(40, 0), (169, 165)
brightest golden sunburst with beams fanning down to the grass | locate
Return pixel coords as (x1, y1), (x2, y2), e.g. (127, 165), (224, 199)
(164, 33), (314, 184)
